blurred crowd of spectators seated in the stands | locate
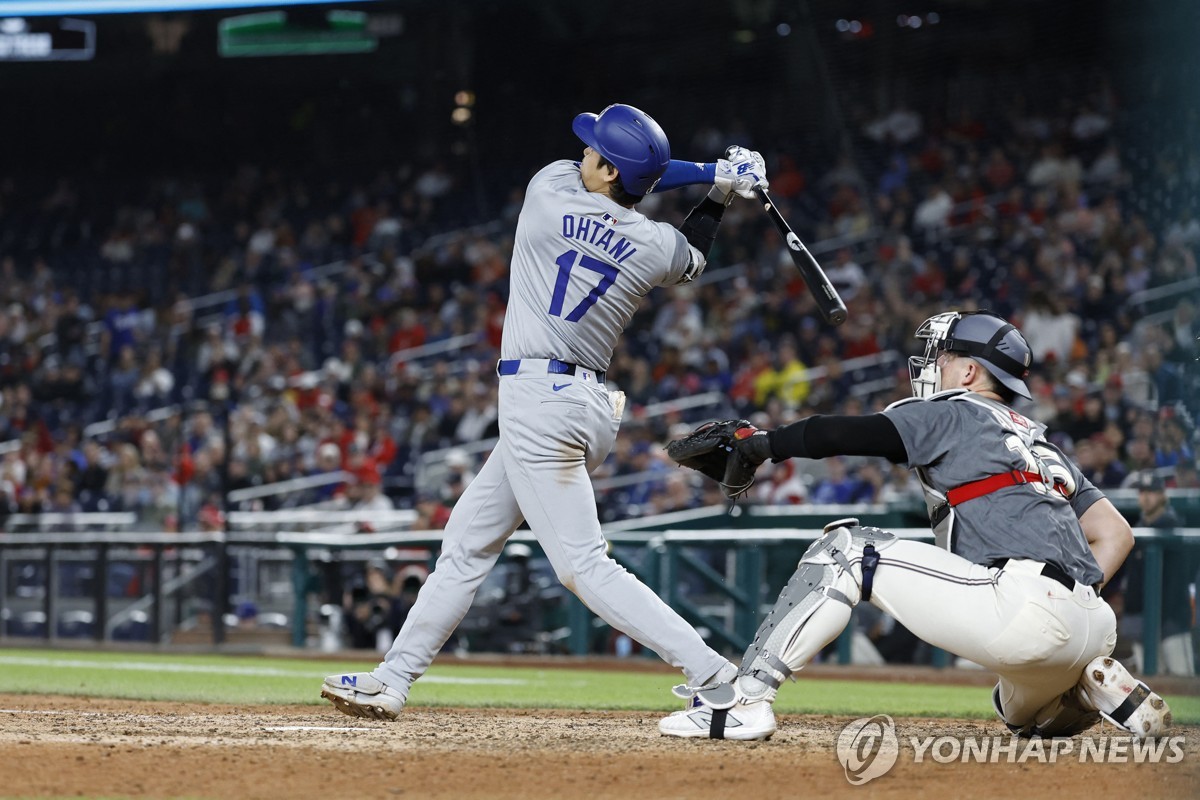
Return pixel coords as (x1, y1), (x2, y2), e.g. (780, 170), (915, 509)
(0, 71), (1200, 530)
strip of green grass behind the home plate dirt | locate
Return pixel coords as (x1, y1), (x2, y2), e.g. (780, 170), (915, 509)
(0, 649), (1200, 724)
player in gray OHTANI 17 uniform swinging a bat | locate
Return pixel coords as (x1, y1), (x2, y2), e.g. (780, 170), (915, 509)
(322, 104), (767, 720)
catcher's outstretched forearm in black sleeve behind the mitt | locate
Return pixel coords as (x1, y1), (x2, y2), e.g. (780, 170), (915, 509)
(768, 414), (908, 464)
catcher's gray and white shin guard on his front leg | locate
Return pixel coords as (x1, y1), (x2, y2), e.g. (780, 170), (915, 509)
(739, 519), (895, 697)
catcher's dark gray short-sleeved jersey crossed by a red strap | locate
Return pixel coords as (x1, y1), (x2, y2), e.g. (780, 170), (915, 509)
(883, 389), (1104, 585)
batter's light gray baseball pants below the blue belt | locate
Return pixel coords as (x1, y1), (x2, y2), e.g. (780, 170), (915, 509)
(372, 359), (728, 697)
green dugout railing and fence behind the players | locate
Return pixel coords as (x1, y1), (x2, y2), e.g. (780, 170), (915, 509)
(0, 522), (1200, 675)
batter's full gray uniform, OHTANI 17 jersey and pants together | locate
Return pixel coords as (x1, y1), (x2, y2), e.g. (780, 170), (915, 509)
(360, 154), (732, 696)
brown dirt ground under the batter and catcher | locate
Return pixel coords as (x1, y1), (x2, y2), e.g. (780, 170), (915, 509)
(0, 694), (1200, 800)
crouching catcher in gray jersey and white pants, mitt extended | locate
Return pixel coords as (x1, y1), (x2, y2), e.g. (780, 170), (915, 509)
(659, 312), (1171, 739)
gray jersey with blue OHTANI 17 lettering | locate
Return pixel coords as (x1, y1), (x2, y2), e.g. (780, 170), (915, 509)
(500, 161), (704, 369)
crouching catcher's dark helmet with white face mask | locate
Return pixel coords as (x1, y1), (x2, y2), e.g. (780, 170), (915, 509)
(908, 311), (1033, 399)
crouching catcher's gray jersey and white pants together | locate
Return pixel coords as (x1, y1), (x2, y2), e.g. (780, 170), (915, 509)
(871, 389), (1116, 723)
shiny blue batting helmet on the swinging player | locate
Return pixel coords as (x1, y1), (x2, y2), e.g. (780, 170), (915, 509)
(571, 103), (671, 197)
